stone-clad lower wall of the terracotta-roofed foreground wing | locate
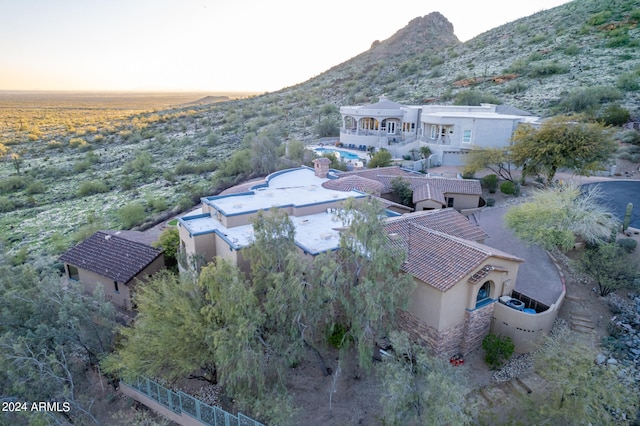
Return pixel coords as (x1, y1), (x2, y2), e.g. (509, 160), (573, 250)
(398, 310), (465, 358)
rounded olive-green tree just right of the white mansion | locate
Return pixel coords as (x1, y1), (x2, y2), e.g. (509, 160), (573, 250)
(511, 116), (617, 182)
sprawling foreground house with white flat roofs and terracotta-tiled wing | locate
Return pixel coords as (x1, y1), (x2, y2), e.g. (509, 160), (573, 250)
(179, 158), (560, 356)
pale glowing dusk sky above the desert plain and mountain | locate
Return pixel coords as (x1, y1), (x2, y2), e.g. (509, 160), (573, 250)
(0, 0), (568, 92)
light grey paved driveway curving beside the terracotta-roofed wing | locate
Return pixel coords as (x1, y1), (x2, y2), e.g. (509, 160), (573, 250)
(476, 205), (562, 306)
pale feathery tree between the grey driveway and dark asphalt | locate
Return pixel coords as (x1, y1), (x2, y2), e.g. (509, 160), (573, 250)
(504, 183), (617, 250)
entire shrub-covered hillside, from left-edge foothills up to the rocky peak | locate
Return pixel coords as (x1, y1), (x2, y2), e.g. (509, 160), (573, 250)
(0, 0), (640, 260)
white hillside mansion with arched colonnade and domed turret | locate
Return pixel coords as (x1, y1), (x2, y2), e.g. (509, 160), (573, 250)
(340, 96), (539, 166)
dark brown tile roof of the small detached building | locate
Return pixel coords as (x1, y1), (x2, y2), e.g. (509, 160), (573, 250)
(60, 231), (162, 283)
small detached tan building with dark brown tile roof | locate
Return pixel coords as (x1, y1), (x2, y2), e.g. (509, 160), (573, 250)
(60, 231), (165, 309)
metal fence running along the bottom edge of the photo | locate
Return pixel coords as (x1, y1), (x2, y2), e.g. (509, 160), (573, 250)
(123, 375), (264, 426)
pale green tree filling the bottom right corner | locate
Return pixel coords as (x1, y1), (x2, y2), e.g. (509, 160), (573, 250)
(518, 327), (638, 425)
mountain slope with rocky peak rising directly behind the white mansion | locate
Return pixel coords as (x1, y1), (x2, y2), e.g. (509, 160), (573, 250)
(215, 0), (640, 140)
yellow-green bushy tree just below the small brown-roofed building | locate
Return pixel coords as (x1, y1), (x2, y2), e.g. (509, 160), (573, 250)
(103, 271), (215, 383)
